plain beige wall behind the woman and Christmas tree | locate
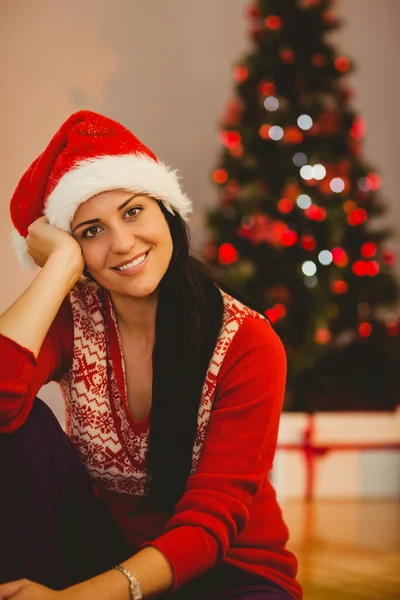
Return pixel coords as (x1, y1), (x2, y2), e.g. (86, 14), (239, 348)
(0, 0), (400, 422)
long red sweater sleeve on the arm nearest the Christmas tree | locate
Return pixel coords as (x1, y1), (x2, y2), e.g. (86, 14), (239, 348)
(148, 317), (286, 589)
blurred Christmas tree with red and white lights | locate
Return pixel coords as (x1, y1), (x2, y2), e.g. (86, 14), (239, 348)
(204, 0), (400, 411)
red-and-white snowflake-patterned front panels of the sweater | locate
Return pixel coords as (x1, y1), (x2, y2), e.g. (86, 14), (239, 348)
(60, 281), (263, 496)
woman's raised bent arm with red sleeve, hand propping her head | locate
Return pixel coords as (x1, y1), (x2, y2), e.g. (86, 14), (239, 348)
(0, 217), (84, 433)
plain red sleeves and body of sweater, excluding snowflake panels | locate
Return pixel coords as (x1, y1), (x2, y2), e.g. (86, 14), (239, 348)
(0, 300), (302, 600)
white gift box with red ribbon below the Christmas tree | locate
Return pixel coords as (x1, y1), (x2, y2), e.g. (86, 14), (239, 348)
(272, 410), (400, 499)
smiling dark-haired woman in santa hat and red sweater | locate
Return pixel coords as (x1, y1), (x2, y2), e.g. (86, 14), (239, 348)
(0, 111), (301, 600)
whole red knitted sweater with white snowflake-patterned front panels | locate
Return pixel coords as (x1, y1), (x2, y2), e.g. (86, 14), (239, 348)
(0, 284), (302, 599)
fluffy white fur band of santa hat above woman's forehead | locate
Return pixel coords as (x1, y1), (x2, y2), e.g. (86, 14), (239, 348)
(44, 154), (192, 231)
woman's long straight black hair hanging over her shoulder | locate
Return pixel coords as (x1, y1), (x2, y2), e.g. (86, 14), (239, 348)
(144, 202), (223, 511)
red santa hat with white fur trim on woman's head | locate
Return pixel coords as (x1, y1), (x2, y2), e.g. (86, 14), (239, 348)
(10, 110), (192, 267)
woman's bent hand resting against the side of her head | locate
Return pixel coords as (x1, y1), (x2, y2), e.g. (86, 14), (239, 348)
(26, 217), (84, 270)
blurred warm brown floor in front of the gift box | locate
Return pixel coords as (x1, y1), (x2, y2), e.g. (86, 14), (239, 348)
(282, 501), (400, 600)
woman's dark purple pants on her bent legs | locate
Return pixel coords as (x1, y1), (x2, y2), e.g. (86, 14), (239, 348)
(0, 398), (292, 600)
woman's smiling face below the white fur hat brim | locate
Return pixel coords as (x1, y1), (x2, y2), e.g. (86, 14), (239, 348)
(71, 190), (173, 297)
